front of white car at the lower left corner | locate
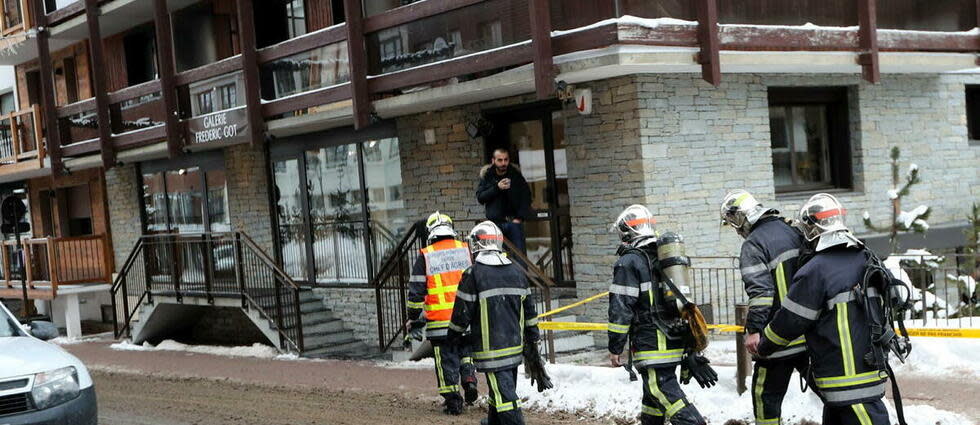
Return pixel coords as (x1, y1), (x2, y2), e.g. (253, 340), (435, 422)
(0, 303), (98, 425)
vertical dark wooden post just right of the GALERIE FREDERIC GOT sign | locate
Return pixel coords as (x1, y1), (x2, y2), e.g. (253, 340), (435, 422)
(235, 0), (265, 146)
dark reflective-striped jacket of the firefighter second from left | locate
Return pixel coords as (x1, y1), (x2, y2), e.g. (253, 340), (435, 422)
(449, 261), (539, 372)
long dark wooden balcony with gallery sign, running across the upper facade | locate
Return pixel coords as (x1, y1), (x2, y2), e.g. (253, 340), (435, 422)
(24, 0), (980, 166)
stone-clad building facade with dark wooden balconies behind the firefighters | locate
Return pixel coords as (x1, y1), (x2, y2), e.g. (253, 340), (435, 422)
(0, 0), (980, 351)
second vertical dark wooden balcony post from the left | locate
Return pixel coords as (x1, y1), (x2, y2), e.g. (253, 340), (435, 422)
(85, 0), (116, 169)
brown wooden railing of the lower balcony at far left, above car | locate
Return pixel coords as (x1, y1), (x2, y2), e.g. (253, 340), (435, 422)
(0, 235), (112, 299)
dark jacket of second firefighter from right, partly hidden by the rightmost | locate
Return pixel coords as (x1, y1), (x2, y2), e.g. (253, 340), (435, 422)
(739, 216), (806, 359)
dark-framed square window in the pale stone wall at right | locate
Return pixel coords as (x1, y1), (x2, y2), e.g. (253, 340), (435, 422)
(769, 87), (852, 193)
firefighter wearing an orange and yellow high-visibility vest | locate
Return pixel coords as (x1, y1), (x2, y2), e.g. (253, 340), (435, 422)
(406, 211), (478, 415)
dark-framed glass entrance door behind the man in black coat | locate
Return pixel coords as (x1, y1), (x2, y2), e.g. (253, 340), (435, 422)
(486, 103), (575, 286)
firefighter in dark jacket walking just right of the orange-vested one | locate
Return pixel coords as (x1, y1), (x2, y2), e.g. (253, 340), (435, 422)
(449, 221), (539, 425)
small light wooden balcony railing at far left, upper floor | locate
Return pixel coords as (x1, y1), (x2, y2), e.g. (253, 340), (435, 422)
(0, 106), (45, 167)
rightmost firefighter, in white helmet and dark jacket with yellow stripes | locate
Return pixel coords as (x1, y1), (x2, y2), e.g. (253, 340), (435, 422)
(757, 193), (890, 425)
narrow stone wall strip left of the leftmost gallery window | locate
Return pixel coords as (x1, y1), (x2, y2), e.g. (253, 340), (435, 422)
(105, 164), (143, 272)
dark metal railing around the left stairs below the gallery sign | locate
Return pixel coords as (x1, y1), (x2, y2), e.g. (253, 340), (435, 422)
(110, 232), (304, 353)
